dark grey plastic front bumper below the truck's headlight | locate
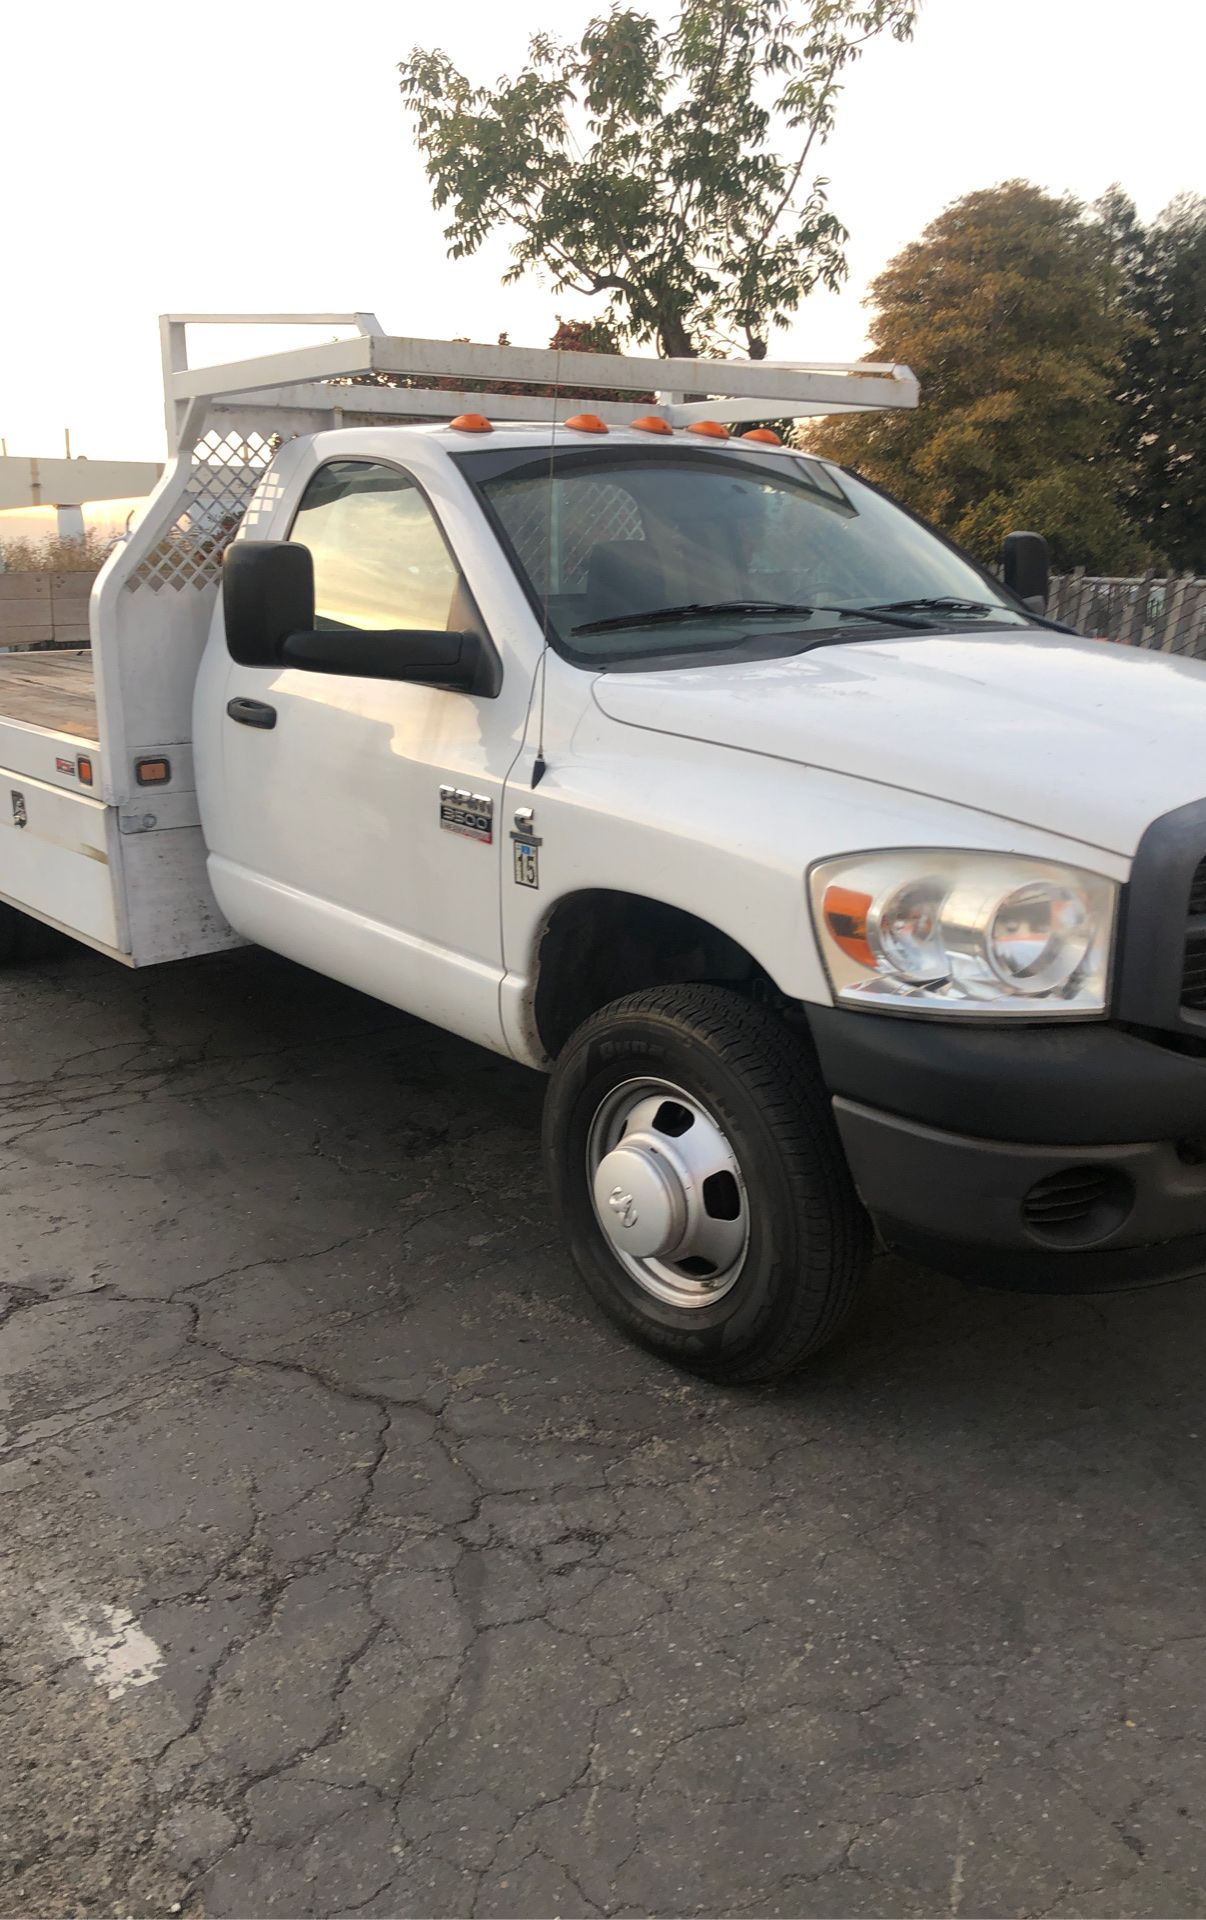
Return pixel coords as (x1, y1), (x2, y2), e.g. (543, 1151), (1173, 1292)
(810, 1008), (1206, 1292)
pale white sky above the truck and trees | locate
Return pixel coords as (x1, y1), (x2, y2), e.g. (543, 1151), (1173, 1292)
(0, 0), (1206, 495)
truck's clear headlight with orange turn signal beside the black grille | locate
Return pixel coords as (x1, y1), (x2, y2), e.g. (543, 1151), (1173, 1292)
(808, 847), (1118, 1020)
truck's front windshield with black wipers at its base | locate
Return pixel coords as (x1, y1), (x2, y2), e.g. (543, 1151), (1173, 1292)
(459, 447), (1027, 664)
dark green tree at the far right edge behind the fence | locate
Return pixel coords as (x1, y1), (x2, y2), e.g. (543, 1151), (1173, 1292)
(1097, 188), (1206, 572)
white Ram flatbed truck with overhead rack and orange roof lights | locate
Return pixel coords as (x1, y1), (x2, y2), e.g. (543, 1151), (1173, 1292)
(0, 315), (1206, 1380)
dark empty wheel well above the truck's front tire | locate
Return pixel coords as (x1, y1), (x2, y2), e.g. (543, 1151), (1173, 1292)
(536, 891), (776, 1058)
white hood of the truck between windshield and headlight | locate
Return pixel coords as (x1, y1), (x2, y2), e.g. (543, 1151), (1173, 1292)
(593, 630), (1206, 856)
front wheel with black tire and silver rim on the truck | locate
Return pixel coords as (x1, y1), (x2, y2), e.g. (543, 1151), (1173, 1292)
(543, 987), (870, 1382)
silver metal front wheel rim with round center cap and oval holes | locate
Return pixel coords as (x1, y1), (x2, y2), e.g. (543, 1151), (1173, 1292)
(586, 1079), (749, 1308)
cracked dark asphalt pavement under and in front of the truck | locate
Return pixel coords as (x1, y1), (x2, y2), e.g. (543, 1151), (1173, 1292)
(0, 950), (1206, 1916)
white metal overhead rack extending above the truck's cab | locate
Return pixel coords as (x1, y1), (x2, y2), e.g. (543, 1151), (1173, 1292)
(159, 313), (918, 453)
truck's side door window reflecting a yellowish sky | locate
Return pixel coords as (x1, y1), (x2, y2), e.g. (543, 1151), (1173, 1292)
(288, 461), (459, 632)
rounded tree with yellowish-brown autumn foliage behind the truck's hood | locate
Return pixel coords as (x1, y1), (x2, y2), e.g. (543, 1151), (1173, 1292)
(808, 180), (1150, 574)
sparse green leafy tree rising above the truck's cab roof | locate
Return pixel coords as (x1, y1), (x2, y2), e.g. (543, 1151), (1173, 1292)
(399, 0), (918, 359)
